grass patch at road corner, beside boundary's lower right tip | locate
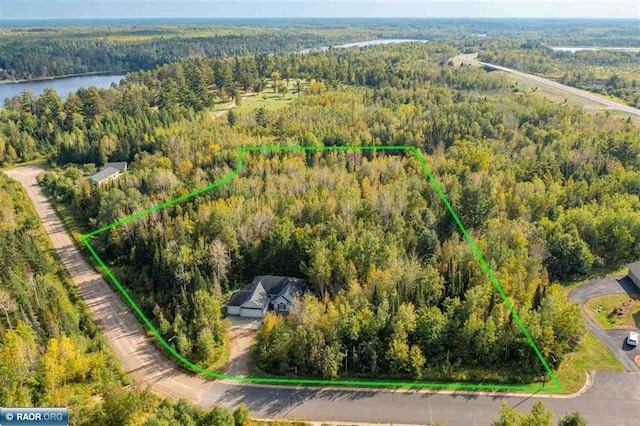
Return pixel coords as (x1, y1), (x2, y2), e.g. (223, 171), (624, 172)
(556, 332), (624, 394)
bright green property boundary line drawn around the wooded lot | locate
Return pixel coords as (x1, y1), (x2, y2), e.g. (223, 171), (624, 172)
(82, 145), (562, 391)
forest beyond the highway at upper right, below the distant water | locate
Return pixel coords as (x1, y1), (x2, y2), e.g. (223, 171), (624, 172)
(479, 41), (640, 108)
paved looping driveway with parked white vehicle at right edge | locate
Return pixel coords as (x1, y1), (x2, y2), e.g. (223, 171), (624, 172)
(569, 277), (640, 372)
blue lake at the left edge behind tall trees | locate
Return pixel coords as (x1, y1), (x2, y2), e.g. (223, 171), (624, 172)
(0, 74), (124, 102)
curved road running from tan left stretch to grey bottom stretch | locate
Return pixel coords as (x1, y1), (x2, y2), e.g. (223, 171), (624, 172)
(5, 166), (640, 426)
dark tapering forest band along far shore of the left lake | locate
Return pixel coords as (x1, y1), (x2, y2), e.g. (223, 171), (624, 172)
(0, 32), (348, 80)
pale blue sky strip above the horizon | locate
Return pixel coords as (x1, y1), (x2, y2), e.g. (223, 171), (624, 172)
(0, 0), (640, 20)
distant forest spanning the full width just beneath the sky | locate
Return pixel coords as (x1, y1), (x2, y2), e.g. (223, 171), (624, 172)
(0, 19), (640, 80)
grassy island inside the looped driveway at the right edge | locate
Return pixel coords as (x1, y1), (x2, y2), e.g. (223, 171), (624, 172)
(584, 294), (640, 329)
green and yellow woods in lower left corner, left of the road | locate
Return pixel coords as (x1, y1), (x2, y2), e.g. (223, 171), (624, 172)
(0, 174), (248, 426)
